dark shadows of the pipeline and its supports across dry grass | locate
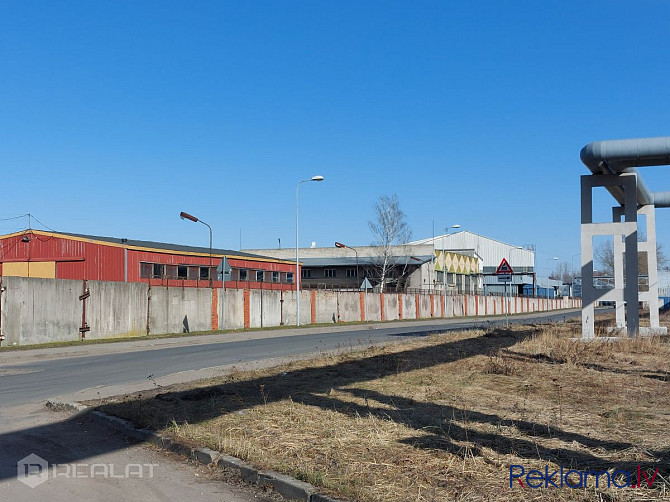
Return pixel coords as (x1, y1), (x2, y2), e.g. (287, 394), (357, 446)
(93, 328), (670, 469)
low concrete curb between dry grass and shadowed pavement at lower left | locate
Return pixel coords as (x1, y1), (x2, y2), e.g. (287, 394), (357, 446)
(46, 399), (341, 502)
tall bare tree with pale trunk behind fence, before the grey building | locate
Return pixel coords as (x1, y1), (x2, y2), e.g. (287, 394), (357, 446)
(368, 194), (412, 290)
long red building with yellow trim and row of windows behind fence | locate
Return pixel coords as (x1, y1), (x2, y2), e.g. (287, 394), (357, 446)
(0, 230), (295, 290)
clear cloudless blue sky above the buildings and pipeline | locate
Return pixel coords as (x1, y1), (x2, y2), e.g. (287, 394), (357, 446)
(0, 0), (670, 271)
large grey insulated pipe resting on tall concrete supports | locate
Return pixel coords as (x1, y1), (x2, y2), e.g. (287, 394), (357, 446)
(579, 136), (670, 207)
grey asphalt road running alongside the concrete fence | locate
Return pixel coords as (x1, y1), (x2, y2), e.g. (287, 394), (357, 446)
(0, 310), (580, 406)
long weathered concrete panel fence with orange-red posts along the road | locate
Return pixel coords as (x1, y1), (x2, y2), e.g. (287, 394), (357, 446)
(0, 277), (581, 345)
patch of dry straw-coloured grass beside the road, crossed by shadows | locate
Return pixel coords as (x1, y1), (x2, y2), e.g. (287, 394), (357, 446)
(93, 314), (670, 501)
